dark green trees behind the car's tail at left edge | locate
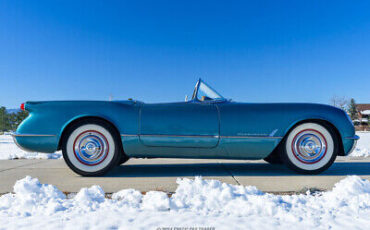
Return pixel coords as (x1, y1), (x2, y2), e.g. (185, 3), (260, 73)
(0, 106), (28, 132)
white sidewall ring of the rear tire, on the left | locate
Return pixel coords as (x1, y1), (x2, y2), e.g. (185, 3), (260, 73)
(66, 124), (116, 172)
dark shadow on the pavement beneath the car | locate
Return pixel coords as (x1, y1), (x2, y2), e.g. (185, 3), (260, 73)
(106, 162), (370, 177)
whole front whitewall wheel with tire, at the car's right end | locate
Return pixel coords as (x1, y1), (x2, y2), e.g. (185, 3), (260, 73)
(281, 122), (339, 174)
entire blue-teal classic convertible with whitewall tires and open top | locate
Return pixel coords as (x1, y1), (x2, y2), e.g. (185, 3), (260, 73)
(13, 79), (358, 176)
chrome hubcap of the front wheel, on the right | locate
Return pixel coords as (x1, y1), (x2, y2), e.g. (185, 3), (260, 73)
(292, 129), (327, 164)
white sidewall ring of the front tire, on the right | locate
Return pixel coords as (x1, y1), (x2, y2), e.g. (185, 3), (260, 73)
(285, 123), (334, 171)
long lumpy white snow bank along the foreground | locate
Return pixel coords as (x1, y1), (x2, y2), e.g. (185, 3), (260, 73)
(0, 176), (370, 230)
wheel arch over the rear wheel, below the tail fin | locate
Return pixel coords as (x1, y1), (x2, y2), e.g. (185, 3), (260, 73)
(58, 115), (124, 153)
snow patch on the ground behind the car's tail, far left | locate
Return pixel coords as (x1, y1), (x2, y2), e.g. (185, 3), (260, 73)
(0, 135), (62, 160)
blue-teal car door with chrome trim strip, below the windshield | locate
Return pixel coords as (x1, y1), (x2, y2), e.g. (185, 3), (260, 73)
(139, 101), (220, 148)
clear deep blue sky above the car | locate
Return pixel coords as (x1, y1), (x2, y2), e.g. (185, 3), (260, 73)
(0, 0), (370, 108)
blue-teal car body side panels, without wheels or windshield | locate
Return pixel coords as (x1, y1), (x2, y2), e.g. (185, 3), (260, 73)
(15, 101), (355, 159)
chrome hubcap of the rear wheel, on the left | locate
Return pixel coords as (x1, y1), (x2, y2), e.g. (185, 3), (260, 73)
(73, 130), (109, 166)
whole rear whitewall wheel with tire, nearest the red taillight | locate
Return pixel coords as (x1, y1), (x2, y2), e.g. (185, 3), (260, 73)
(62, 119), (122, 176)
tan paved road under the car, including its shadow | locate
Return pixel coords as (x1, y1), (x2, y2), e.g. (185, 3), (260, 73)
(0, 158), (370, 193)
